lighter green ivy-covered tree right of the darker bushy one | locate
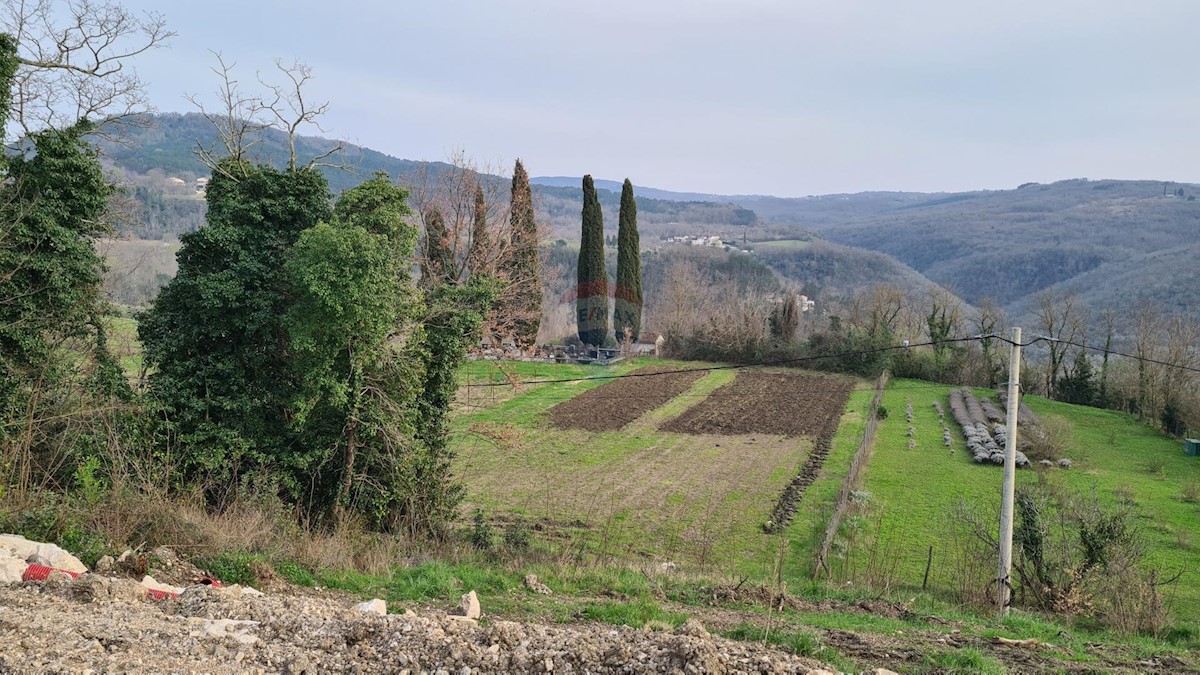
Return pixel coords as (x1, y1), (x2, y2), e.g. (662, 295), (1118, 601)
(287, 175), (421, 526)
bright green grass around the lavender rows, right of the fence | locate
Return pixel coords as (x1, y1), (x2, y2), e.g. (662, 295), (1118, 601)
(848, 380), (1200, 622)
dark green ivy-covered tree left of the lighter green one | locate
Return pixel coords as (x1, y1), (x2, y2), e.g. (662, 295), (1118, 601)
(138, 160), (331, 501)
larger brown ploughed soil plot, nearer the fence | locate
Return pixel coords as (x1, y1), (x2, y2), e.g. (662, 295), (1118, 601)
(661, 371), (853, 437)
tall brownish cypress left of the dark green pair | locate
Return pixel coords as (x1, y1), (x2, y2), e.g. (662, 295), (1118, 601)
(508, 160), (541, 350)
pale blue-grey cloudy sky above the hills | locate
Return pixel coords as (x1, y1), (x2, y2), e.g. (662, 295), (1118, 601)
(122, 0), (1200, 196)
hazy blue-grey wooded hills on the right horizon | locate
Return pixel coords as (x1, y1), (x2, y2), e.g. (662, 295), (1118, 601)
(544, 178), (1200, 319)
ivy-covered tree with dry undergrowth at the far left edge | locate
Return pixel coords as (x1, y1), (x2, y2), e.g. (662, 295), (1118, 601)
(0, 31), (131, 490)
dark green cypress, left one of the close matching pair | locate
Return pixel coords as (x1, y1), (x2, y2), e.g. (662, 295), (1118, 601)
(575, 175), (608, 347)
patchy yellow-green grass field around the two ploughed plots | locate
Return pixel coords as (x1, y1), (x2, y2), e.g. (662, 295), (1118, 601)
(455, 362), (853, 578)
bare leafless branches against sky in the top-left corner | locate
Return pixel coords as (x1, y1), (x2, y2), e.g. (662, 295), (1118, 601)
(0, 0), (175, 141)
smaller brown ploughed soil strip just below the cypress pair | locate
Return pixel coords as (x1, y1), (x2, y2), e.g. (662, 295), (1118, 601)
(547, 366), (704, 431)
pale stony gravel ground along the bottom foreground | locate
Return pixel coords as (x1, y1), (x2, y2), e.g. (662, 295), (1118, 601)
(0, 574), (835, 675)
